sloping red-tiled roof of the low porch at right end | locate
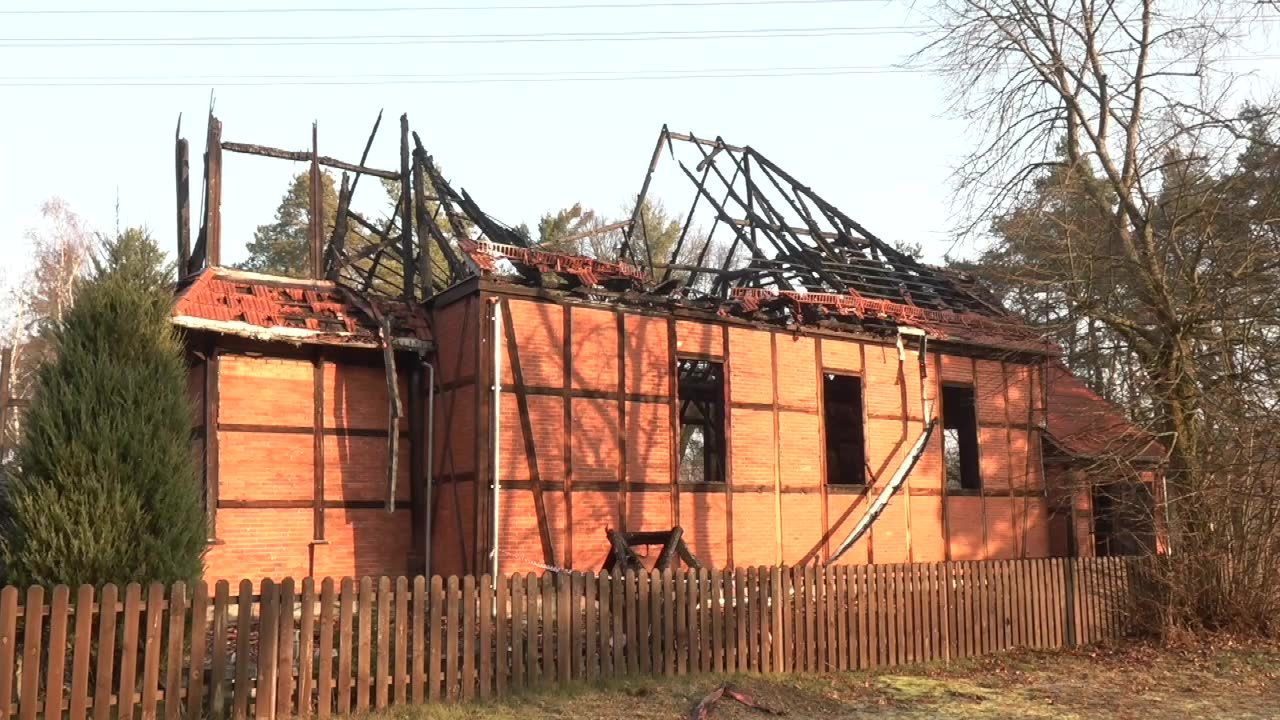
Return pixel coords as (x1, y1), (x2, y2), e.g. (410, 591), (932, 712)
(1047, 363), (1165, 462)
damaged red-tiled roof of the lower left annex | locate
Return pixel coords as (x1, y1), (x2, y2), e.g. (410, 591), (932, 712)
(173, 268), (431, 347)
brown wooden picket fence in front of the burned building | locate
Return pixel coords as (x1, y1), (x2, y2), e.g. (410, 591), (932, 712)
(0, 559), (1139, 720)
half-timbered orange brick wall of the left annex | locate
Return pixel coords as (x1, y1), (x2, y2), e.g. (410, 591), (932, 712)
(191, 345), (411, 580)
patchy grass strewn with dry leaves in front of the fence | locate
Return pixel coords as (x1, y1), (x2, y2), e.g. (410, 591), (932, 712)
(367, 641), (1280, 720)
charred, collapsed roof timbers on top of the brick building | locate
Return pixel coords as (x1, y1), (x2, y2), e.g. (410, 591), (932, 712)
(177, 114), (1052, 354)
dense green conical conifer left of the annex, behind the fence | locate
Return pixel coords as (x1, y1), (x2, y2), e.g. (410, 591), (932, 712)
(0, 229), (206, 585)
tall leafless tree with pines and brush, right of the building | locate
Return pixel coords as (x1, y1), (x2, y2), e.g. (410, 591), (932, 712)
(919, 0), (1280, 632)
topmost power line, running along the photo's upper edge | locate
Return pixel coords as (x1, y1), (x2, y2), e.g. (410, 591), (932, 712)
(0, 0), (884, 15)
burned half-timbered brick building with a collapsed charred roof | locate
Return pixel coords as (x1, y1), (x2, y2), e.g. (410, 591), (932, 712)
(174, 118), (1162, 578)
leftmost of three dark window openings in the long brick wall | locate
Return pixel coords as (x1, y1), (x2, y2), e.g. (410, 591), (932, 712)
(676, 360), (724, 483)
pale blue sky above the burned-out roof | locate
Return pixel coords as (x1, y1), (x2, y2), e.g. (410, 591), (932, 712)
(0, 0), (1275, 278)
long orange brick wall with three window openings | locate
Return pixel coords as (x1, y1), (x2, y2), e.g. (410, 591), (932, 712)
(488, 296), (1050, 571)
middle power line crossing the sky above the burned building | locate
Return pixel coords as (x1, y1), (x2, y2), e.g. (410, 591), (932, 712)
(0, 26), (932, 47)
